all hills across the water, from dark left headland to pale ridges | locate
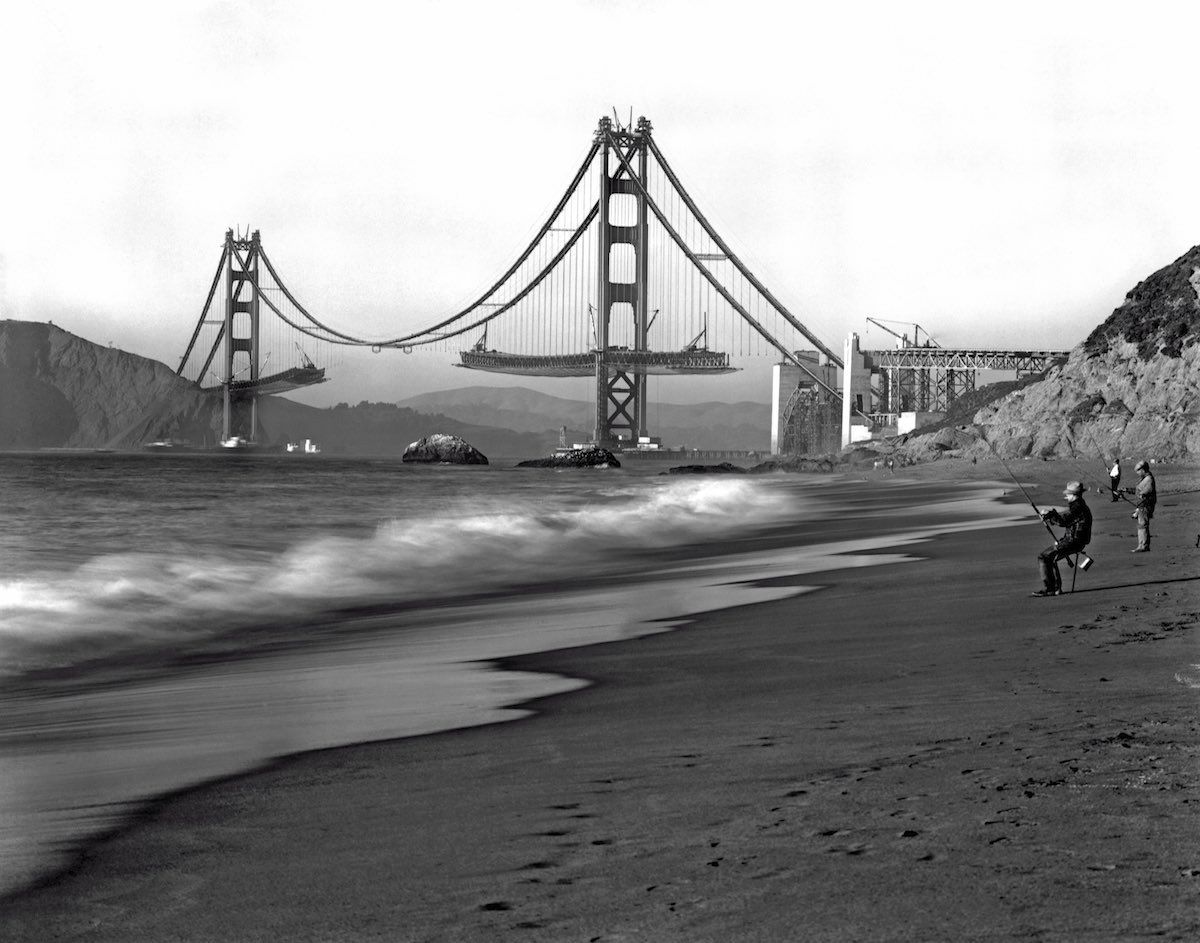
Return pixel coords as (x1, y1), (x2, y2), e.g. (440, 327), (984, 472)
(0, 320), (770, 458)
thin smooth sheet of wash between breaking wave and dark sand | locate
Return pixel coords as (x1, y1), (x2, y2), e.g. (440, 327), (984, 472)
(0, 481), (1009, 896)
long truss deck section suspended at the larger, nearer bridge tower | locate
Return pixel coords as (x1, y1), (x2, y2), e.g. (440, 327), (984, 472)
(458, 349), (738, 377)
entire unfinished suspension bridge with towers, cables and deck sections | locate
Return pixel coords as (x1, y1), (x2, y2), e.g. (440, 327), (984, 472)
(176, 118), (1060, 452)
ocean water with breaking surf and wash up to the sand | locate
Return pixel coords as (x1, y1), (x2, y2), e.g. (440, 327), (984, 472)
(0, 452), (1012, 893)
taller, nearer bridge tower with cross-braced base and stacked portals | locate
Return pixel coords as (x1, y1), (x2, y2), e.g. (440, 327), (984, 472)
(593, 118), (652, 446)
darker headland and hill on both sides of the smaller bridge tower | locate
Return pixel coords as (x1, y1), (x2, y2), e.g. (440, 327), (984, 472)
(0, 320), (544, 457)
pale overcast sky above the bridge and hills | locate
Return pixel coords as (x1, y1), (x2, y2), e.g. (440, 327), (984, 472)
(0, 0), (1200, 404)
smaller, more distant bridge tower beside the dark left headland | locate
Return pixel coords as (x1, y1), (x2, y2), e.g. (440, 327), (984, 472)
(221, 229), (262, 442)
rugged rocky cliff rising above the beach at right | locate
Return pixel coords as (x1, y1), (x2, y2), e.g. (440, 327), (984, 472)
(901, 246), (1200, 461)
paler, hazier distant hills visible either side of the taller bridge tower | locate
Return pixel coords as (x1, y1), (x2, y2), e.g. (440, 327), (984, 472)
(397, 386), (770, 450)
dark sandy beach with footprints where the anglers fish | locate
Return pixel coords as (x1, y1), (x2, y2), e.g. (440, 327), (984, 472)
(0, 462), (1200, 942)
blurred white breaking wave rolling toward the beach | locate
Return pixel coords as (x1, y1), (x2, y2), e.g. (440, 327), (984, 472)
(0, 479), (788, 674)
